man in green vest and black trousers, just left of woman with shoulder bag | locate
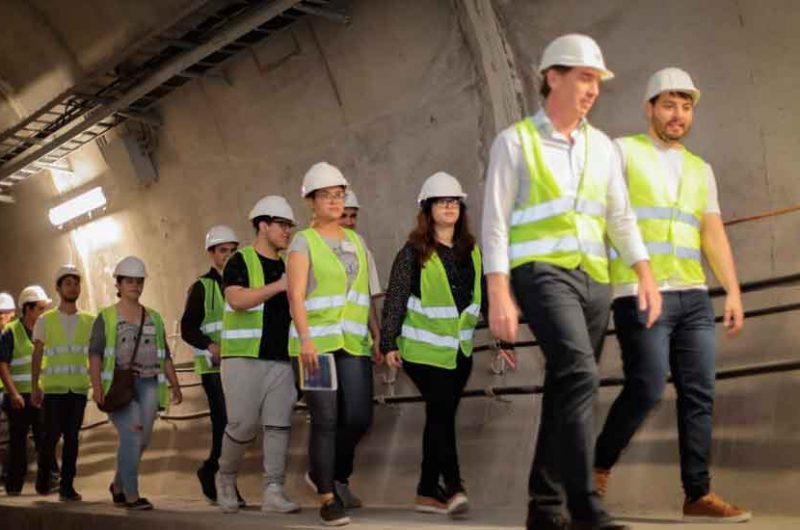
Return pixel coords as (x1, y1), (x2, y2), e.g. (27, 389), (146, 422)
(31, 265), (94, 502)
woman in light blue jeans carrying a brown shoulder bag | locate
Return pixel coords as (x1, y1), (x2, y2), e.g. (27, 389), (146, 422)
(89, 256), (183, 510)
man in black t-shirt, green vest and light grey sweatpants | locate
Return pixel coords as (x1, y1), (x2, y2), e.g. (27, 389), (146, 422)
(216, 195), (299, 513)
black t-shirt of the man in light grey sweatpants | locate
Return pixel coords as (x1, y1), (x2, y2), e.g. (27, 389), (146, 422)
(222, 253), (292, 361)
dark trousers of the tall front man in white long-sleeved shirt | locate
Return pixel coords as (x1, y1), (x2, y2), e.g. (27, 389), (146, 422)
(511, 263), (610, 521)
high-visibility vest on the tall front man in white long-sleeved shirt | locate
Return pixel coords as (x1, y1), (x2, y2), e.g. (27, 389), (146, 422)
(509, 118), (610, 283)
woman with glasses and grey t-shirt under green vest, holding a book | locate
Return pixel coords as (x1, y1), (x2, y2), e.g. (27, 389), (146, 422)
(287, 162), (372, 526)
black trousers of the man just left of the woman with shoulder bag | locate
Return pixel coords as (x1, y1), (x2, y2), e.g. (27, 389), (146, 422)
(36, 392), (86, 492)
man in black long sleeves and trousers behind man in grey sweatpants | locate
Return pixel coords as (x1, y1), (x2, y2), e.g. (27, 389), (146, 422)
(181, 225), (239, 503)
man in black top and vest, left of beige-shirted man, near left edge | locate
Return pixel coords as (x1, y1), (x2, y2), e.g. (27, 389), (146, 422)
(0, 285), (51, 496)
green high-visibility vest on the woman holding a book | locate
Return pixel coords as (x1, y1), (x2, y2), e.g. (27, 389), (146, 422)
(289, 228), (372, 357)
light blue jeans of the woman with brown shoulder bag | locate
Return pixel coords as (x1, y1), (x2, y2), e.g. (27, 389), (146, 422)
(109, 377), (158, 501)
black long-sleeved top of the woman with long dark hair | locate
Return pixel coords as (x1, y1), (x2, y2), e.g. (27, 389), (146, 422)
(380, 243), (487, 353)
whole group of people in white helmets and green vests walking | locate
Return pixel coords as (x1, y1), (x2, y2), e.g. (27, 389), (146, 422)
(0, 34), (750, 530)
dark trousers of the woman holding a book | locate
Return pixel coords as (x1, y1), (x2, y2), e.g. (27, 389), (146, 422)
(293, 350), (372, 494)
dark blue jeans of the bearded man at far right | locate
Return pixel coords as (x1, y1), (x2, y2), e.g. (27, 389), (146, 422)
(595, 290), (715, 499)
